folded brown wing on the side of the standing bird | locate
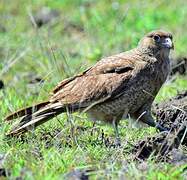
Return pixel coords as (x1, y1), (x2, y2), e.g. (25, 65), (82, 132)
(50, 56), (135, 108)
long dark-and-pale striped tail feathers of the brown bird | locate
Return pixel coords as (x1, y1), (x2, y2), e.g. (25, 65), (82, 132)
(5, 102), (74, 136)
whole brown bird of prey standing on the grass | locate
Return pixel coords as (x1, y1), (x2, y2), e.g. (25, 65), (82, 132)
(6, 30), (174, 143)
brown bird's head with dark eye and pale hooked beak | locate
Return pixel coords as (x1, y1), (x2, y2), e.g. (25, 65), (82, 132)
(138, 30), (174, 55)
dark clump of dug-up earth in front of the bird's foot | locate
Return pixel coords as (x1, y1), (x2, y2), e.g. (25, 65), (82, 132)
(133, 91), (187, 163)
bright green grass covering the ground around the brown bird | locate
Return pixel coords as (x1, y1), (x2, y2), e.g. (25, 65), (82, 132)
(0, 0), (187, 179)
